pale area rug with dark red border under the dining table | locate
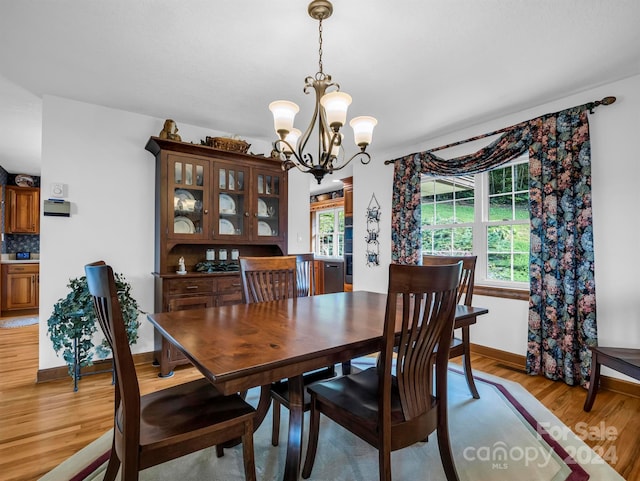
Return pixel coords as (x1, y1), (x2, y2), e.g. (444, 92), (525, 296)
(41, 361), (624, 481)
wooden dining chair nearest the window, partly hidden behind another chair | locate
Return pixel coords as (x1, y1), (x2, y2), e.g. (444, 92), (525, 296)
(422, 255), (480, 399)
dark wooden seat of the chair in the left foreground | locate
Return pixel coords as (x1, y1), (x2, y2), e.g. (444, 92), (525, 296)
(137, 378), (256, 450)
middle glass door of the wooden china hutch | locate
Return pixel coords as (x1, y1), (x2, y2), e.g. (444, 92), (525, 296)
(214, 163), (249, 239)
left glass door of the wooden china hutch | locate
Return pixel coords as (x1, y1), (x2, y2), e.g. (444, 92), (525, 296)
(168, 156), (209, 239)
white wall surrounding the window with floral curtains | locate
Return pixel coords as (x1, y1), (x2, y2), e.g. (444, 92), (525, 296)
(354, 76), (640, 380)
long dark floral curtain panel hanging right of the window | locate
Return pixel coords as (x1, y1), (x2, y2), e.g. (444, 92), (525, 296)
(527, 108), (597, 386)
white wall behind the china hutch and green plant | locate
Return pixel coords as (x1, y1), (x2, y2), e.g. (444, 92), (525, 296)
(39, 96), (270, 369)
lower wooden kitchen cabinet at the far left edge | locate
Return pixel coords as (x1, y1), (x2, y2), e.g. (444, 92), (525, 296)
(2, 264), (40, 311)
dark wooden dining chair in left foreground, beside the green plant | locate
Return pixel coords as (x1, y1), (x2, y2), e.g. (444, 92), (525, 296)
(85, 261), (256, 481)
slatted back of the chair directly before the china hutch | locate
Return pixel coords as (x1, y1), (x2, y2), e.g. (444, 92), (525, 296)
(240, 256), (298, 304)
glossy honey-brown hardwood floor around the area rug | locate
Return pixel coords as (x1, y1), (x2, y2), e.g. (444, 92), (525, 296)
(0, 326), (640, 481)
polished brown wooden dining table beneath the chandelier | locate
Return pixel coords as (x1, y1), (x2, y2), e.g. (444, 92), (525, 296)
(147, 291), (488, 481)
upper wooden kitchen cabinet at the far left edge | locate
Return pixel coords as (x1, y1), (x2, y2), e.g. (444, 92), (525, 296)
(4, 185), (40, 234)
